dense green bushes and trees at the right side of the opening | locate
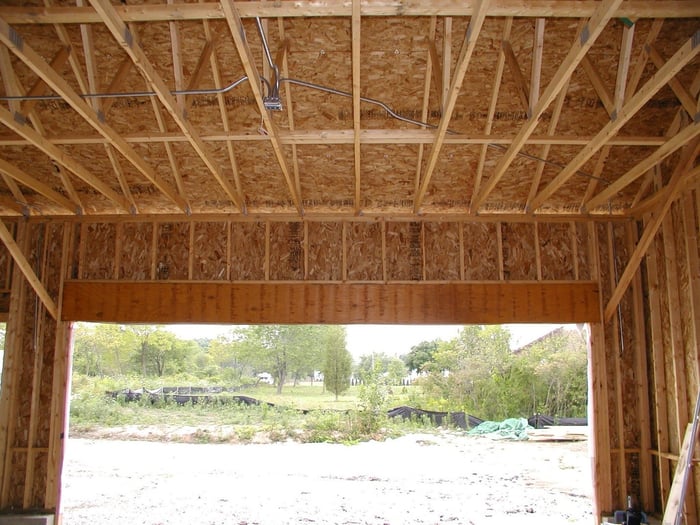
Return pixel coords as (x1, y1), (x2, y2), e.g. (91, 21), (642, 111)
(422, 326), (587, 420)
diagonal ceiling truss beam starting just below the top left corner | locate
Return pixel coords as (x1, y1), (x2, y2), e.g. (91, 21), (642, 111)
(0, 19), (187, 211)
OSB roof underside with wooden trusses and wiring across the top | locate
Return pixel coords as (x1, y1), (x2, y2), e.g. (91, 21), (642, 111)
(0, 0), (700, 219)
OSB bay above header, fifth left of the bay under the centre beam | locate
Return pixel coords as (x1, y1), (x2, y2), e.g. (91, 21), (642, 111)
(156, 222), (190, 279)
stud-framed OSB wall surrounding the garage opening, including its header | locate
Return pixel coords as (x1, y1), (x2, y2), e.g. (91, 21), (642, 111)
(0, 208), (700, 524)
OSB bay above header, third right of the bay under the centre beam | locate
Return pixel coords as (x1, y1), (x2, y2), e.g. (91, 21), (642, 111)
(464, 222), (501, 281)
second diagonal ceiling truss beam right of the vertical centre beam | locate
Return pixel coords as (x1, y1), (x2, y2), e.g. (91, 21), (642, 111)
(473, 0), (621, 209)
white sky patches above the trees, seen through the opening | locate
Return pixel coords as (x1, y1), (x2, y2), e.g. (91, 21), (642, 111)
(169, 324), (562, 358)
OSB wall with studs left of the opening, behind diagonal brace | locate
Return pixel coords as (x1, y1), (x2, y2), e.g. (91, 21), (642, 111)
(0, 223), (70, 510)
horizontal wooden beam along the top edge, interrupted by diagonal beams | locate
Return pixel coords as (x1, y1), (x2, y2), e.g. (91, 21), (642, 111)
(0, 0), (700, 24)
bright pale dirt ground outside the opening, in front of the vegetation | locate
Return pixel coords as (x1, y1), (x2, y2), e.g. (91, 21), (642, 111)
(63, 432), (594, 525)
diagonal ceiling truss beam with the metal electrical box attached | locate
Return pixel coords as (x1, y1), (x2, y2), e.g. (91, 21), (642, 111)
(221, 0), (304, 215)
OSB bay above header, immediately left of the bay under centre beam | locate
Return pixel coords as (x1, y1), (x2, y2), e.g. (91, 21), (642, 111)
(307, 222), (343, 281)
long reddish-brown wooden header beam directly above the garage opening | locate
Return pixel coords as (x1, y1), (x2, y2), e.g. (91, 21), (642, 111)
(61, 281), (600, 324)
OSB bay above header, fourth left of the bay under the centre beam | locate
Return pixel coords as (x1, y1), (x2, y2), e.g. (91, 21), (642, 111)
(192, 222), (228, 281)
